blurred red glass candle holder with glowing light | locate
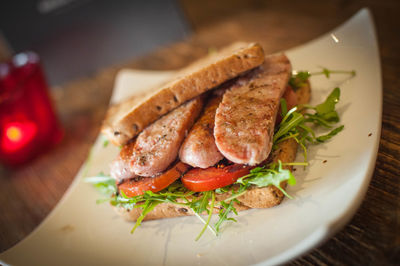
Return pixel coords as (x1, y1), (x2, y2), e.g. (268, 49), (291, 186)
(0, 52), (63, 166)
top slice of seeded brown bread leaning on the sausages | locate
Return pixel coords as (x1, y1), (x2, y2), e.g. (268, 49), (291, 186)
(102, 43), (264, 145)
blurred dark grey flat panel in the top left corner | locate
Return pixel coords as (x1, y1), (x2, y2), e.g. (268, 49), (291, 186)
(0, 0), (190, 85)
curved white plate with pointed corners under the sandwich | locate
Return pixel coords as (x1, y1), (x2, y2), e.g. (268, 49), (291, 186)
(0, 9), (382, 265)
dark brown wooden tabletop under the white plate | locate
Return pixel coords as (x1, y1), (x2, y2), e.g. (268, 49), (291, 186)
(0, 0), (400, 265)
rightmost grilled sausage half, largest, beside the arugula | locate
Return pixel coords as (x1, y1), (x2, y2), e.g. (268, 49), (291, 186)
(214, 54), (291, 165)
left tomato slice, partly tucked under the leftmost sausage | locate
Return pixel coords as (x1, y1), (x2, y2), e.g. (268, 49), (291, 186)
(118, 162), (190, 197)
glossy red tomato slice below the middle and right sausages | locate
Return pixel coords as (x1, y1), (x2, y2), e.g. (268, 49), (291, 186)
(182, 164), (251, 192)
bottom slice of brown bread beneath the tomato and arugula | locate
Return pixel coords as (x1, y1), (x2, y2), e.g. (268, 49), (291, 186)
(114, 80), (311, 221)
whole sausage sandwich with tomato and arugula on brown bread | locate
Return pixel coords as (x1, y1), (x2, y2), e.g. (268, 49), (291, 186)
(87, 43), (343, 239)
